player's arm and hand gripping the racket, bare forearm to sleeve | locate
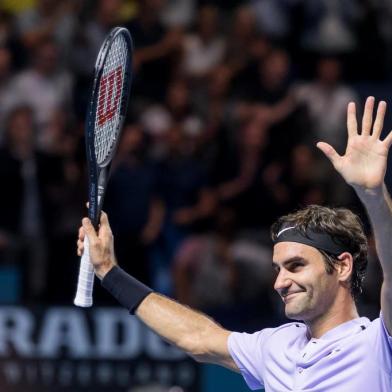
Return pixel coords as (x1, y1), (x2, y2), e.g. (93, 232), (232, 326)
(78, 213), (239, 372)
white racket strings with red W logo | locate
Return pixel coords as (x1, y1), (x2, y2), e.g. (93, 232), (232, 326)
(94, 34), (129, 165)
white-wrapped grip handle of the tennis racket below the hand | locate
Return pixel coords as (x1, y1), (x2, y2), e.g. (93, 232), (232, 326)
(74, 236), (94, 308)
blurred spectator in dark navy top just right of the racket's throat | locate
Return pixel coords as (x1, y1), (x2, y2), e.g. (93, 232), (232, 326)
(105, 124), (163, 282)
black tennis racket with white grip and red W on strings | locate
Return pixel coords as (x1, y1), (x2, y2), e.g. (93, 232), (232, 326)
(74, 27), (133, 307)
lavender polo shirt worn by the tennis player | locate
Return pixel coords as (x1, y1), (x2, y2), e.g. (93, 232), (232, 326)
(228, 314), (392, 392)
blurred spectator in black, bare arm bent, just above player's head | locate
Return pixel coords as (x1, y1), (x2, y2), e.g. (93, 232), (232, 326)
(213, 117), (287, 228)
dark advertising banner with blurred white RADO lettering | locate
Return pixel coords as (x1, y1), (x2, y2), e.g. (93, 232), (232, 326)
(0, 306), (200, 392)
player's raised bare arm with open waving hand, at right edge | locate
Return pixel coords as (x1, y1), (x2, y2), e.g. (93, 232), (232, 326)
(317, 97), (392, 335)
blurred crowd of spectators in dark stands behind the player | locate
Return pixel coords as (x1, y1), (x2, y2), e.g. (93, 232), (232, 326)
(0, 0), (392, 329)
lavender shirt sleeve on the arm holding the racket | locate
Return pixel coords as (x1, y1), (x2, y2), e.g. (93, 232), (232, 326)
(228, 329), (269, 390)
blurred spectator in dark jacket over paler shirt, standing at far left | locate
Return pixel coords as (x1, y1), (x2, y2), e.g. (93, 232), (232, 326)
(0, 106), (63, 300)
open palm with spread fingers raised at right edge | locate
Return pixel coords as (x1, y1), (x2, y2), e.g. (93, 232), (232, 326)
(317, 97), (392, 190)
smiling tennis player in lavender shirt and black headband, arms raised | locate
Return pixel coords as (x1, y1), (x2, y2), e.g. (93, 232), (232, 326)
(78, 97), (392, 392)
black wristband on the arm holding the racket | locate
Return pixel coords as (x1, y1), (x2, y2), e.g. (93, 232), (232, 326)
(101, 266), (153, 314)
